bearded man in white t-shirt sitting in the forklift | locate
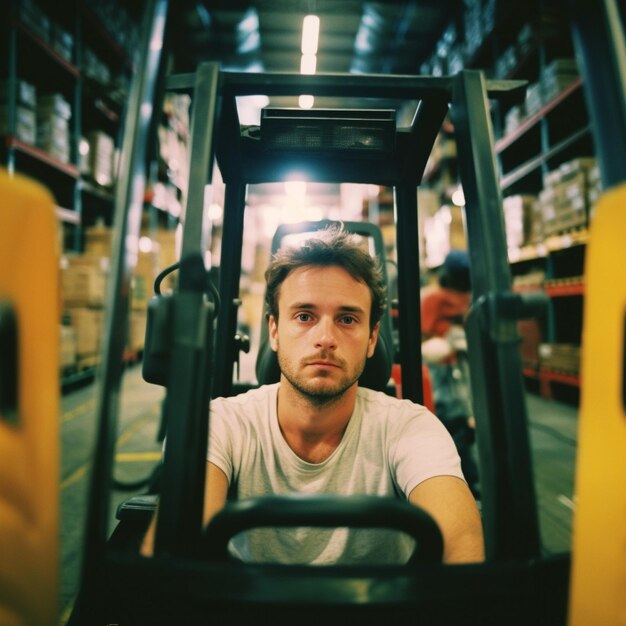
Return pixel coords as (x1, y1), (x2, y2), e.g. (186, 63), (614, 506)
(143, 228), (483, 564)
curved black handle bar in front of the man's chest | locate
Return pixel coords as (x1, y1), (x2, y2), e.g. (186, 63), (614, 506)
(203, 494), (443, 563)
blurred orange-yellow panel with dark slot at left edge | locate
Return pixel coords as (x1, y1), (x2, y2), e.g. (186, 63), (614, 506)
(0, 170), (60, 626)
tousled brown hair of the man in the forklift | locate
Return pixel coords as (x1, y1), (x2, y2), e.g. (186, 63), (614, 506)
(265, 226), (387, 329)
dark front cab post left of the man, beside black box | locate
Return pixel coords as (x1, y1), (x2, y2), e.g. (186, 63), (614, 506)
(155, 63), (219, 554)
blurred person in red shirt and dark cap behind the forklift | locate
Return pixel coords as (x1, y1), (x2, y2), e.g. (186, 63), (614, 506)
(421, 250), (479, 497)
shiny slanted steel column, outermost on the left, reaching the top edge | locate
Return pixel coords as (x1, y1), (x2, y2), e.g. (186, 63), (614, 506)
(78, 0), (168, 572)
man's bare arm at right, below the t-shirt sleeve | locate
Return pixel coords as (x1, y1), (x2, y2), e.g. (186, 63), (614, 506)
(409, 476), (485, 563)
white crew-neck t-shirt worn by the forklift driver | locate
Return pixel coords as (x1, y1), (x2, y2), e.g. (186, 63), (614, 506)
(208, 383), (463, 565)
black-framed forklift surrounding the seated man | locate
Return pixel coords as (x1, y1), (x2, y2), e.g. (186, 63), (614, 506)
(2, 0), (626, 626)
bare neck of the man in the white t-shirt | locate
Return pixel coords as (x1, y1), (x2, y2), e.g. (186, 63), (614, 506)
(276, 380), (357, 463)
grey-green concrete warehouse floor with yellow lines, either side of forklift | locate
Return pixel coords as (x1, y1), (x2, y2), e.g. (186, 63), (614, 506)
(59, 365), (577, 626)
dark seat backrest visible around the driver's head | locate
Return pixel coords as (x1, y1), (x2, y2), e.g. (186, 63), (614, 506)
(256, 220), (394, 391)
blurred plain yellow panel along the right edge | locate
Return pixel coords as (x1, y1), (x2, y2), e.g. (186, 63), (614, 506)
(569, 185), (626, 626)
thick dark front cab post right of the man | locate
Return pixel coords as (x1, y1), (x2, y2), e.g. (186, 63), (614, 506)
(452, 70), (540, 559)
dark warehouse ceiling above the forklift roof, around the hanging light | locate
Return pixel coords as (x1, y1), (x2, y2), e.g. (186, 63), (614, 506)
(168, 0), (463, 74)
